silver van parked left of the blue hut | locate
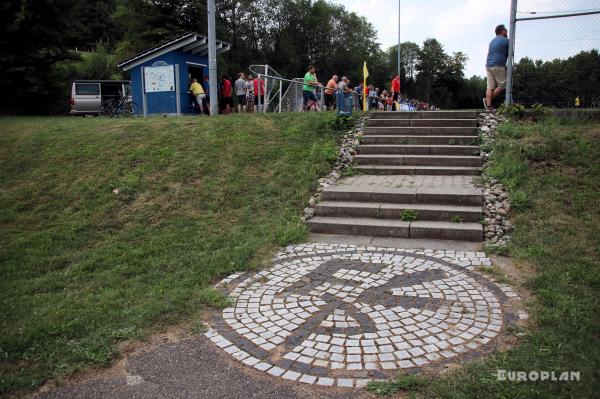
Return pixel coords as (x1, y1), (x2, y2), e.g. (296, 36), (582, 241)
(70, 80), (131, 115)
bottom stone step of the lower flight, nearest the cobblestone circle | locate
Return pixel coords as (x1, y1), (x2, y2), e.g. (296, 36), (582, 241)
(308, 216), (483, 241)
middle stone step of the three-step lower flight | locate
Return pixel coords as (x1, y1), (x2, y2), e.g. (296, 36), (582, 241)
(316, 201), (482, 223)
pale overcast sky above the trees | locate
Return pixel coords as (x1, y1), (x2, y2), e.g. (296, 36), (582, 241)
(332, 0), (600, 77)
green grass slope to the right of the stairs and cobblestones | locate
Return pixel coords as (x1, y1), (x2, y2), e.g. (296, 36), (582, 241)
(372, 119), (600, 398)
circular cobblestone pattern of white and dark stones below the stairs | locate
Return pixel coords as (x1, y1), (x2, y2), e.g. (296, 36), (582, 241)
(206, 244), (517, 387)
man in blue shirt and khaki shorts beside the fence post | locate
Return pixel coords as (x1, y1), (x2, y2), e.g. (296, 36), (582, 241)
(483, 25), (508, 112)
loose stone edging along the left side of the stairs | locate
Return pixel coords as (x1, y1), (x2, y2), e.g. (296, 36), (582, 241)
(300, 116), (367, 222)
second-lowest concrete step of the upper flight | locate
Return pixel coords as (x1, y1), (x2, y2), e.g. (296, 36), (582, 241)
(354, 153), (481, 167)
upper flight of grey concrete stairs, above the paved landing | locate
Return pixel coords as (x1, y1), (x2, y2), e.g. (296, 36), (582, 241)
(354, 111), (481, 175)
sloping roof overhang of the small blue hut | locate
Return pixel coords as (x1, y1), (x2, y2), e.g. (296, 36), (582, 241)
(117, 32), (231, 71)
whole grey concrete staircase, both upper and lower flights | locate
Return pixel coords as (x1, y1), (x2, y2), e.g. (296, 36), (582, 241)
(309, 111), (483, 241)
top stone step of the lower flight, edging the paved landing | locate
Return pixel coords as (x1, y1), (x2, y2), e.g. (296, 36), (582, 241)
(321, 186), (483, 207)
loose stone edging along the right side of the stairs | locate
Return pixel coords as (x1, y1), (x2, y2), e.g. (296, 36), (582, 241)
(477, 112), (513, 248)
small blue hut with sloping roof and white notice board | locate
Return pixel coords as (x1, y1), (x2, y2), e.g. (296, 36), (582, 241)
(118, 32), (231, 116)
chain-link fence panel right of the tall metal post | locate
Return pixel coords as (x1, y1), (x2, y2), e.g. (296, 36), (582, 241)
(512, 0), (600, 108)
